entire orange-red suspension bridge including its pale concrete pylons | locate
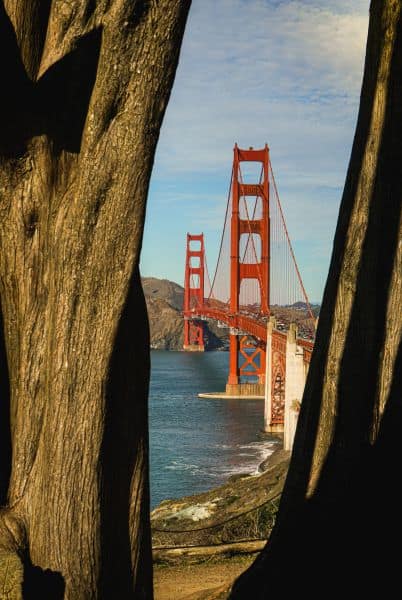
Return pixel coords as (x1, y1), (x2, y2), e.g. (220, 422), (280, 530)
(183, 144), (315, 432)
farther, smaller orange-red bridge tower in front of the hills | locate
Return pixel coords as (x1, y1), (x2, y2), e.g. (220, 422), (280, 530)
(183, 233), (205, 352)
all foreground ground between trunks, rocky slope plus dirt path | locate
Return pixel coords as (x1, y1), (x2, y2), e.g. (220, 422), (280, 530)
(151, 444), (290, 600)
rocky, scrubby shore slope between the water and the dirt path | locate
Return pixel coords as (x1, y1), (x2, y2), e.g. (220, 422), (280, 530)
(151, 449), (289, 562)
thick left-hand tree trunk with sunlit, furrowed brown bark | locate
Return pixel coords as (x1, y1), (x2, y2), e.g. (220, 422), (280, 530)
(0, 0), (191, 600)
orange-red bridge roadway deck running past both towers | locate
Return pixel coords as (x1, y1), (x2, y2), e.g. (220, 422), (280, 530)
(183, 306), (314, 354)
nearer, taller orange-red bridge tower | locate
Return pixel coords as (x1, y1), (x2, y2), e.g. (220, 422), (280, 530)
(226, 144), (270, 393)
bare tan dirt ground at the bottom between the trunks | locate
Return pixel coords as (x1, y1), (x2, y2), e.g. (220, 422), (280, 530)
(154, 554), (256, 600)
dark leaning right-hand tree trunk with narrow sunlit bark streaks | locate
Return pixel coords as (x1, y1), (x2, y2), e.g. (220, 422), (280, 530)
(230, 0), (402, 600)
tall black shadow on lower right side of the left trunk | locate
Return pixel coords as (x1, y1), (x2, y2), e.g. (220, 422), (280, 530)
(100, 269), (152, 598)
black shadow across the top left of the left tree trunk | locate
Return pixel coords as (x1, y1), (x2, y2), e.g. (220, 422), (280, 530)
(0, 2), (102, 158)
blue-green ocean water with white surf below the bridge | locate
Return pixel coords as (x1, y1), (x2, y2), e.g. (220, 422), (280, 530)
(150, 350), (276, 508)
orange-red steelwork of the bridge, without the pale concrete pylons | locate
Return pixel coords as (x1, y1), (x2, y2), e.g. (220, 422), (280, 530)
(183, 144), (314, 422)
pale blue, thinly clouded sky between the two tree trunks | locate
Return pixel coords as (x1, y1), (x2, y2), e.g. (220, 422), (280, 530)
(141, 0), (369, 302)
